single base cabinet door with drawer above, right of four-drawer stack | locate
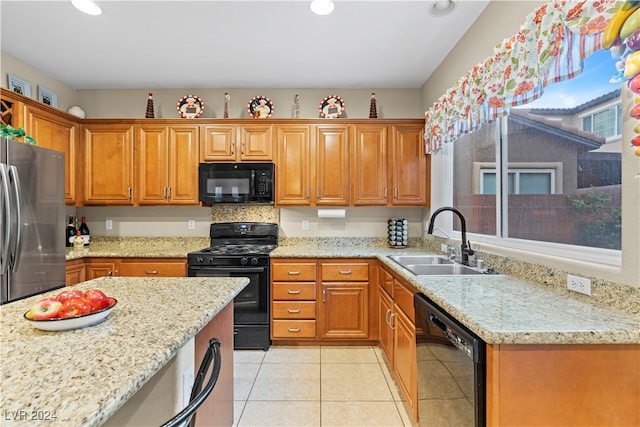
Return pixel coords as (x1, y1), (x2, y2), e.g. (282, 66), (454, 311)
(318, 260), (369, 339)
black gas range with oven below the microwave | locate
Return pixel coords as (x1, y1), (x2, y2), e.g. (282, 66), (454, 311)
(187, 222), (278, 351)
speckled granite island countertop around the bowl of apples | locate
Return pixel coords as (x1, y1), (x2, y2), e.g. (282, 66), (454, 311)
(0, 277), (248, 427)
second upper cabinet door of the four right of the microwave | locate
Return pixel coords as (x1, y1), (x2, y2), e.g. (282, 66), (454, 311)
(315, 125), (350, 206)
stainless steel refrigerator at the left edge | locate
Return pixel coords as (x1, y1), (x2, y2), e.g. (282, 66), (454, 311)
(0, 138), (66, 304)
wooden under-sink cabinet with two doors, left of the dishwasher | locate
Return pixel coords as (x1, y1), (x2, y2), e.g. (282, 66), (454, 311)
(378, 266), (418, 419)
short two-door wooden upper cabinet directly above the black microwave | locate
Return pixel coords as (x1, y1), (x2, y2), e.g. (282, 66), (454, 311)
(200, 123), (273, 162)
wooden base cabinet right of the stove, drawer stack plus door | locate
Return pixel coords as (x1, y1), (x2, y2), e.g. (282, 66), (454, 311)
(271, 258), (377, 343)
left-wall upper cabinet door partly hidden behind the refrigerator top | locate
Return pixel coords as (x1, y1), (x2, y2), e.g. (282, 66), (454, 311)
(25, 107), (82, 205)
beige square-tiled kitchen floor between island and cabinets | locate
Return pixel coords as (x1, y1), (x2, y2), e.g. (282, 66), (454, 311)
(234, 346), (411, 427)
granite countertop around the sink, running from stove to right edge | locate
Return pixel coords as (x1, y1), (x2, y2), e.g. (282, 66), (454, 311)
(271, 241), (640, 344)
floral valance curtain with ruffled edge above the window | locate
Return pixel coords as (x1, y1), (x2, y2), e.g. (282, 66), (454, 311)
(425, 0), (623, 152)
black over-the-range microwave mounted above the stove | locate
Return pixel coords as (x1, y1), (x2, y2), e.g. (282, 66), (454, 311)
(199, 163), (275, 205)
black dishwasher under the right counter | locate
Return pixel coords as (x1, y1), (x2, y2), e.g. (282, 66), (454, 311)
(414, 293), (486, 427)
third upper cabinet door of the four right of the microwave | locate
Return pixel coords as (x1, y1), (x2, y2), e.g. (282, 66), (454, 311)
(351, 124), (388, 206)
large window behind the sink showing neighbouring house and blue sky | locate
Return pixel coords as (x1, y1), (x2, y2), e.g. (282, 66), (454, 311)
(451, 51), (622, 250)
